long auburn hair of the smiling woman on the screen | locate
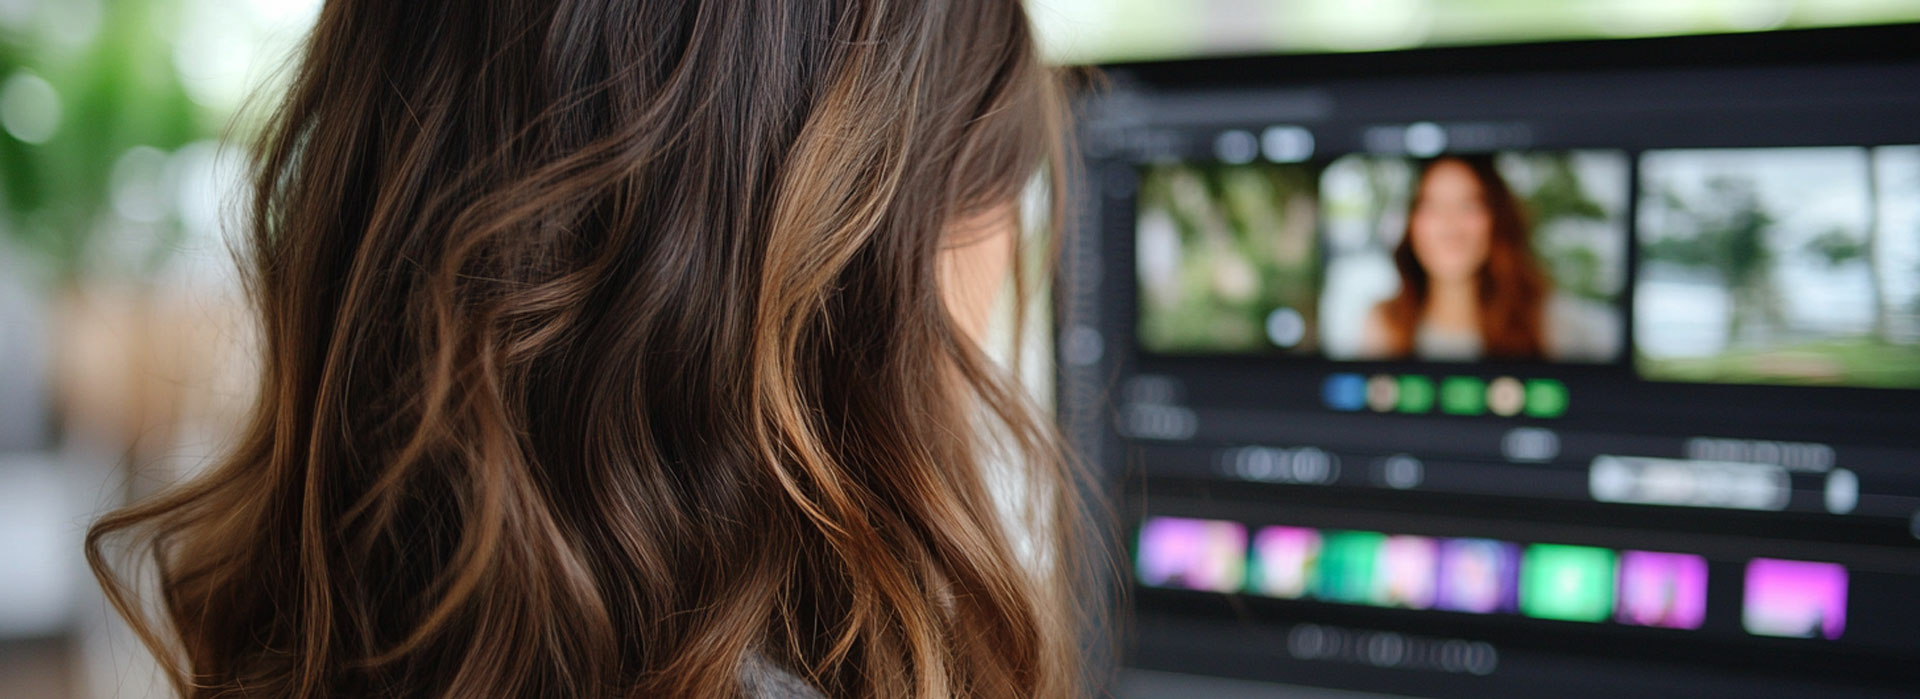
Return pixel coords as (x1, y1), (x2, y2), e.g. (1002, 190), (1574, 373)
(1380, 156), (1549, 361)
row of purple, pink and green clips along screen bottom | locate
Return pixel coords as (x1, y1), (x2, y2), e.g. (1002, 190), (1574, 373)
(1135, 517), (1847, 639)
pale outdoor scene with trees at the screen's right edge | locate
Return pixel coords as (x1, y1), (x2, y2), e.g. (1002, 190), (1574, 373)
(1634, 146), (1920, 388)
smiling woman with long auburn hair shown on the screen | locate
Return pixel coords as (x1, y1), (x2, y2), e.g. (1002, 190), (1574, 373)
(1363, 156), (1551, 361)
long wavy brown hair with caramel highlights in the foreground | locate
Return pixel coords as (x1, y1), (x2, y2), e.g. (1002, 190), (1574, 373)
(88, 0), (1085, 697)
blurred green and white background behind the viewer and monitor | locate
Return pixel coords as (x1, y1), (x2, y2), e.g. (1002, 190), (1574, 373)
(0, 0), (1920, 699)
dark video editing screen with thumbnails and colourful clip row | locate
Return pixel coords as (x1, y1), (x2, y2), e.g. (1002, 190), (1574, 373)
(1060, 29), (1920, 697)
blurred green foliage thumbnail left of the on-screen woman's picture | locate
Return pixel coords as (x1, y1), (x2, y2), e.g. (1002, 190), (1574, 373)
(1135, 163), (1319, 353)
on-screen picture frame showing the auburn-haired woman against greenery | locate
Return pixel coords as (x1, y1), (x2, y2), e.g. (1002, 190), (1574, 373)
(1319, 150), (1628, 363)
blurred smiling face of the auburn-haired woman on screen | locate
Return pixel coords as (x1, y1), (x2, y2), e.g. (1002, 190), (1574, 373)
(1407, 159), (1494, 282)
